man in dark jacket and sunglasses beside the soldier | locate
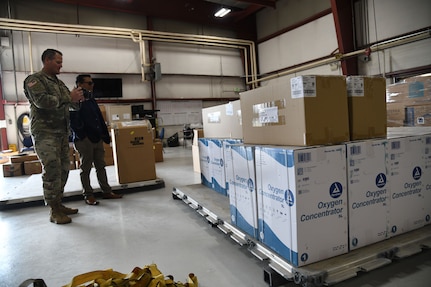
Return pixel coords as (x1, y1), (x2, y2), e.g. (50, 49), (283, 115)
(70, 75), (122, 205)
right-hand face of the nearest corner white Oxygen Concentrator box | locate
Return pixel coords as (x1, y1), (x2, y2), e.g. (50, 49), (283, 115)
(287, 145), (348, 266)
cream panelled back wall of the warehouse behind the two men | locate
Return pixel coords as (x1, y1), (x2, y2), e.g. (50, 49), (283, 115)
(0, 0), (245, 147)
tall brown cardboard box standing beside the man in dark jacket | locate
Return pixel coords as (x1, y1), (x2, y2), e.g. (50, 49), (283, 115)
(111, 120), (156, 184)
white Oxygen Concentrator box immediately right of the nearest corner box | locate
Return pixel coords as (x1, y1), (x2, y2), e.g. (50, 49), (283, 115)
(346, 139), (390, 250)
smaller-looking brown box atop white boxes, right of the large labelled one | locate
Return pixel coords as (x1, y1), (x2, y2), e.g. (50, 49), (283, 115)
(346, 76), (387, 140)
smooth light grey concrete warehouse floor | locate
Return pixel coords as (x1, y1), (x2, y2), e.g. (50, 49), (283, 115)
(0, 146), (431, 287)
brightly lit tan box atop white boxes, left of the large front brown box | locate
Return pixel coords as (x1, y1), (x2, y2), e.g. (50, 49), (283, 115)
(202, 100), (242, 138)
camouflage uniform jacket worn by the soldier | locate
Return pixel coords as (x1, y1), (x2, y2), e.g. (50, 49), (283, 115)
(24, 71), (78, 134)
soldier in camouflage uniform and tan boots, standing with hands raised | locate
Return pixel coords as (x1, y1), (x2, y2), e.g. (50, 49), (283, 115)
(24, 49), (84, 224)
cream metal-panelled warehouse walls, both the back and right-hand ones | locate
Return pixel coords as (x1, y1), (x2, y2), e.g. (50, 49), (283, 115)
(0, 0), (431, 150)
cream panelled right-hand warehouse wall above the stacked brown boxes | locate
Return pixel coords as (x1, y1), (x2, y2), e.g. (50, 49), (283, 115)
(257, 0), (431, 81)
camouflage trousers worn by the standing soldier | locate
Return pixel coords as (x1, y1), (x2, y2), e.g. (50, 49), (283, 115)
(33, 133), (70, 204)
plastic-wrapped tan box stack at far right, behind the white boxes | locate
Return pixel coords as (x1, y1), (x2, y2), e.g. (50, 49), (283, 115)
(386, 74), (431, 127)
